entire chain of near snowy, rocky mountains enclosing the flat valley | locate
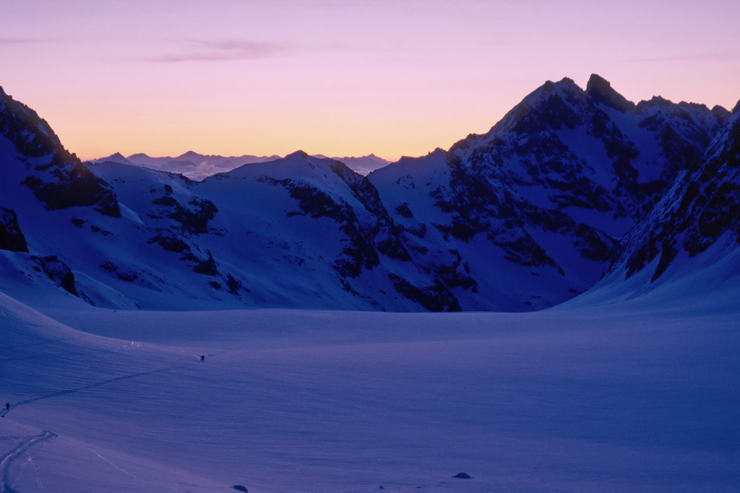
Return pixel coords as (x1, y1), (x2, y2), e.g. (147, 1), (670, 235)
(0, 75), (738, 311)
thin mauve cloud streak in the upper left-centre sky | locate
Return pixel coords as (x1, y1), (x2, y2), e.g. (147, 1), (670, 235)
(143, 39), (290, 63)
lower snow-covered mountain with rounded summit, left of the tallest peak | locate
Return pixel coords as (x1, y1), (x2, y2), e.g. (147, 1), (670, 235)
(88, 151), (459, 310)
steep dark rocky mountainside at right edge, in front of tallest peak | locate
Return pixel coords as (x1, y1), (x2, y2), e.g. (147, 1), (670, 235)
(578, 108), (740, 303)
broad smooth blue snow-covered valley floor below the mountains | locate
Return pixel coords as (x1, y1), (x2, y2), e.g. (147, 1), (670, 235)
(0, 294), (740, 493)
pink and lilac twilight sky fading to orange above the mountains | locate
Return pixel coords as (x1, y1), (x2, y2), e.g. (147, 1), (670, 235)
(0, 0), (740, 160)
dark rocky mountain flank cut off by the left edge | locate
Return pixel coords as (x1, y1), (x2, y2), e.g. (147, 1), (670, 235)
(0, 88), (121, 299)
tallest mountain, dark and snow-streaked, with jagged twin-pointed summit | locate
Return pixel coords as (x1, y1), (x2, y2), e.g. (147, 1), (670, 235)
(369, 75), (729, 311)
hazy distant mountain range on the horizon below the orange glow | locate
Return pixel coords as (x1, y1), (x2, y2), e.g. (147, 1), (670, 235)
(90, 151), (389, 181)
